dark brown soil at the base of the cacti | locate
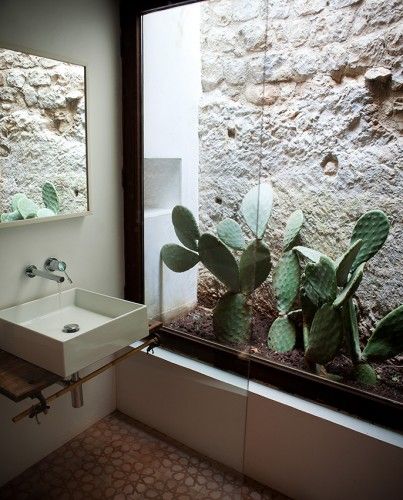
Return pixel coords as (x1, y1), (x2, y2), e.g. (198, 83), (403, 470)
(167, 306), (403, 403)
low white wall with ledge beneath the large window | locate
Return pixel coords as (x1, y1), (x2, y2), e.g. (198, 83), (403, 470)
(117, 348), (403, 500)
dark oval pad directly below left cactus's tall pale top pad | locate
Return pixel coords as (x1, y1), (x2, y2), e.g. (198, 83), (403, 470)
(239, 240), (271, 293)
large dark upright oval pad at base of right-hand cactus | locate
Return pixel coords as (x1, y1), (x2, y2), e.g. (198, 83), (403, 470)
(305, 304), (343, 365)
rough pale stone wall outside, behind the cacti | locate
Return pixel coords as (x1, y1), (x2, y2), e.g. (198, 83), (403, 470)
(199, 0), (403, 327)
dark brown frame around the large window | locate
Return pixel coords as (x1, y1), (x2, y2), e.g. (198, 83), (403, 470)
(120, 0), (403, 430)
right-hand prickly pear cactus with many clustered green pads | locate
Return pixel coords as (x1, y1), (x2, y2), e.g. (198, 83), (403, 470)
(268, 210), (403, 384)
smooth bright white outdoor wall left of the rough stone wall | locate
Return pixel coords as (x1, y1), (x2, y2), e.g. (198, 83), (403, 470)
(144, 4), (201, 316)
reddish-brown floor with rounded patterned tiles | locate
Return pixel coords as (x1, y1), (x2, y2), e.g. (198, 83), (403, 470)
(0, 412), (285, 500)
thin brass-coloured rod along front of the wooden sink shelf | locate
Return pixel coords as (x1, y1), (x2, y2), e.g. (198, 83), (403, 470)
(12, 323), (161, 423)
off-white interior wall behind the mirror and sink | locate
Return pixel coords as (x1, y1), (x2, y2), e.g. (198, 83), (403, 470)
(0, 0), (123, 484)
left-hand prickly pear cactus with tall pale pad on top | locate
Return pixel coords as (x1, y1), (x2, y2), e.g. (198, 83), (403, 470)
(161, 184), (273, 344)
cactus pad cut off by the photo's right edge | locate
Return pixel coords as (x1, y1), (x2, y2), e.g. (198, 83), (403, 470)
(362, 304), (403, 360)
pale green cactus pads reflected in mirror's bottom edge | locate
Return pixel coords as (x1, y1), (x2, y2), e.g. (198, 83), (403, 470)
(0, 182), (60, 222)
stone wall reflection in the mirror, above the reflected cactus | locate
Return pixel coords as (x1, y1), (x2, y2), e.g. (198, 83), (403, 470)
(0, 48), (88, 222)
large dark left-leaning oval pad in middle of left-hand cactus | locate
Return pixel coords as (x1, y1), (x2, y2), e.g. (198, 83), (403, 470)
(199, 233), (240, 292)
